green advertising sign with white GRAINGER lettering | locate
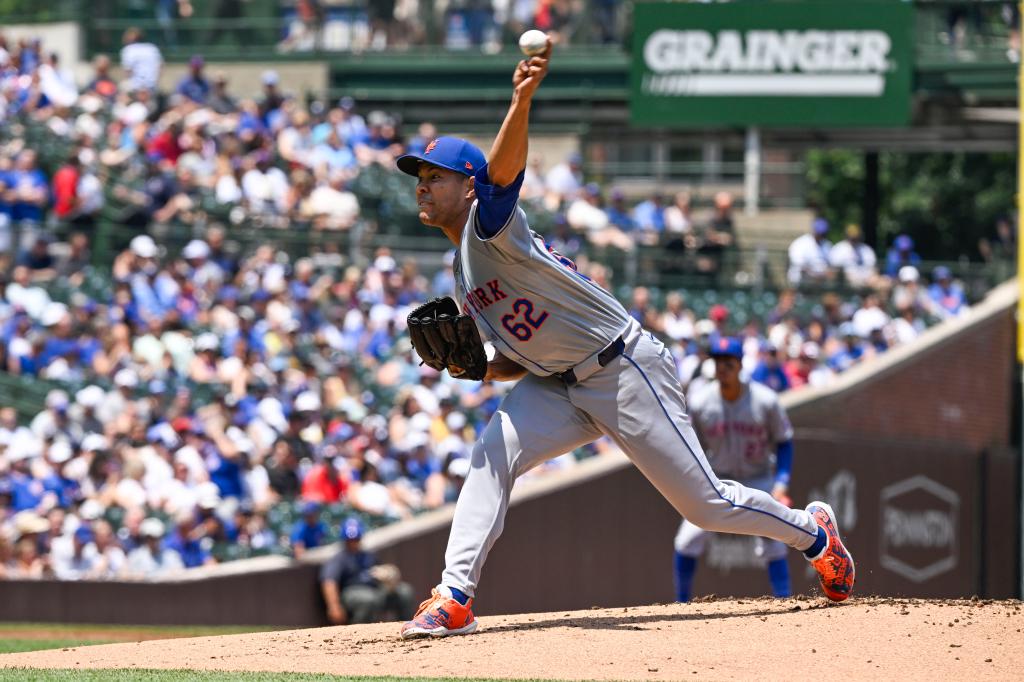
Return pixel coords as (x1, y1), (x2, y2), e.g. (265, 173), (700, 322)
(630, 0), (913, 127)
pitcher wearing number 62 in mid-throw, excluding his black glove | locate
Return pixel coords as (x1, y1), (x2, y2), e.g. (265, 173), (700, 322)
(397, 38), (853, 637)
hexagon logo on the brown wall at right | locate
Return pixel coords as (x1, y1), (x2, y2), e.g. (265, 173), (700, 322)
(880, 475), (961, 583)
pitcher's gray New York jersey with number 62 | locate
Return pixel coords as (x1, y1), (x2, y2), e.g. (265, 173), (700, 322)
(455, 203), (630, 376)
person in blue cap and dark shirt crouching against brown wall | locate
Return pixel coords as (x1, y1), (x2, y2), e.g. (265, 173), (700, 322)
(321, 519), (413, 625)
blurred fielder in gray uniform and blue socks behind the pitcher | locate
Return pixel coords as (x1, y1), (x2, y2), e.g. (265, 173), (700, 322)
(675, 337), (793, 601)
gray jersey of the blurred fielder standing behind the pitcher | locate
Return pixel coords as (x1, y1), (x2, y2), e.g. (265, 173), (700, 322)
(690, 381), (793, 480)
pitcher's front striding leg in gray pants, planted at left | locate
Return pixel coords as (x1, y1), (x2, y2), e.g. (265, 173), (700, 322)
(441, 376), (601, 596)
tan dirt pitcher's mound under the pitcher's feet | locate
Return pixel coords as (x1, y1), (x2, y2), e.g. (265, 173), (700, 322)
(0, 598), (1024, 680)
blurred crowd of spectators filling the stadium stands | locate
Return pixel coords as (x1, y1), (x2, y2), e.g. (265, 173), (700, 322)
(0, 29), (983, 579)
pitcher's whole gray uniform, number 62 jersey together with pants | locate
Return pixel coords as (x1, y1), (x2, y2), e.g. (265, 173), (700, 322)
(441, 193), (818, 596)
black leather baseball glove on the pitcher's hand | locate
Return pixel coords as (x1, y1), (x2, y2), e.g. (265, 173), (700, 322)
(408, 296), (487, 381)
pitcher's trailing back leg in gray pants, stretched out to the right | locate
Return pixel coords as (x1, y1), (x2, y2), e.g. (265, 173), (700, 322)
(570, 333), (818, 550)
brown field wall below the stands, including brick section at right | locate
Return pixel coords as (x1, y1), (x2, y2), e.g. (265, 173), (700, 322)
(0, 310), (1020, 627)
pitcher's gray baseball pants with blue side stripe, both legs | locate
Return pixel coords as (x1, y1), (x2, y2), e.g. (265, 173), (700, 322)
(441, 315), (818, 596)
